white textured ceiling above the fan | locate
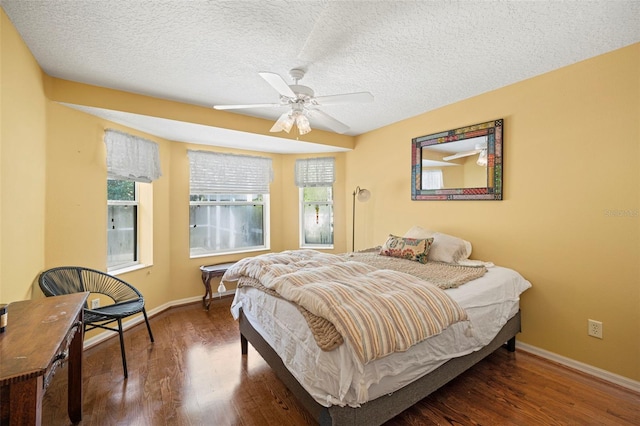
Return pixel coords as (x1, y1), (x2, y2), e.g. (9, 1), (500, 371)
(0, 0), (640, 152)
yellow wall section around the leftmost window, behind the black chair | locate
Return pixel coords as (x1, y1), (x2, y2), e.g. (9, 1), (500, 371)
(44, 102), (172, 308)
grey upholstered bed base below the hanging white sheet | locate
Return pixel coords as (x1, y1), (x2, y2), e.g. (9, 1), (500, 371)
(239, 312), (520, 426)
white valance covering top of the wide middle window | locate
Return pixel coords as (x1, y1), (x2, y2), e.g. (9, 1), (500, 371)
(188, 150), (273, 194)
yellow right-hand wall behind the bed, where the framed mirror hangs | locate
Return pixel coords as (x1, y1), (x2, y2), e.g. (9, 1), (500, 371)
(345, 44), (640, 380)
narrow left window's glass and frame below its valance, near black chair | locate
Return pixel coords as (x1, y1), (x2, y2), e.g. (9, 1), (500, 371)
(107, 179), (138, 270)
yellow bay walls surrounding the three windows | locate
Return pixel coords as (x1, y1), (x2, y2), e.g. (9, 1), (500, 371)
(45, 102), (345, 308)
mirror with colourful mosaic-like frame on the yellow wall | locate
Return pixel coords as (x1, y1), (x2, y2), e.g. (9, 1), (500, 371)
(411, 118), (504, 201)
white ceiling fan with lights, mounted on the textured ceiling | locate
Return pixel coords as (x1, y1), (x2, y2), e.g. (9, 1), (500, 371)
(213, 68), (373, 135)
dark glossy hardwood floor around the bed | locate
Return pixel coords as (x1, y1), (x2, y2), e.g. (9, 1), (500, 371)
(42, 298), (640, 426)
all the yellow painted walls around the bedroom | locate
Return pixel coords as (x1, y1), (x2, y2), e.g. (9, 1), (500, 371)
(0, 8), (640, 380)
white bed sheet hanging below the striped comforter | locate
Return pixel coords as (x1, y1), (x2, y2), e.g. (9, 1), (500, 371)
(231, 266), (531, 407)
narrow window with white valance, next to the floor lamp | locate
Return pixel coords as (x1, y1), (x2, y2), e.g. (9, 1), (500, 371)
(296, 157), (335, 248)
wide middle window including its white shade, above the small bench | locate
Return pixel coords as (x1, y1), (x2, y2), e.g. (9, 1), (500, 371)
(189, 151), (273, 257)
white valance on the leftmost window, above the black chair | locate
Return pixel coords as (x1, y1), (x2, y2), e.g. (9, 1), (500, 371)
(104, 129), (162, 183)
